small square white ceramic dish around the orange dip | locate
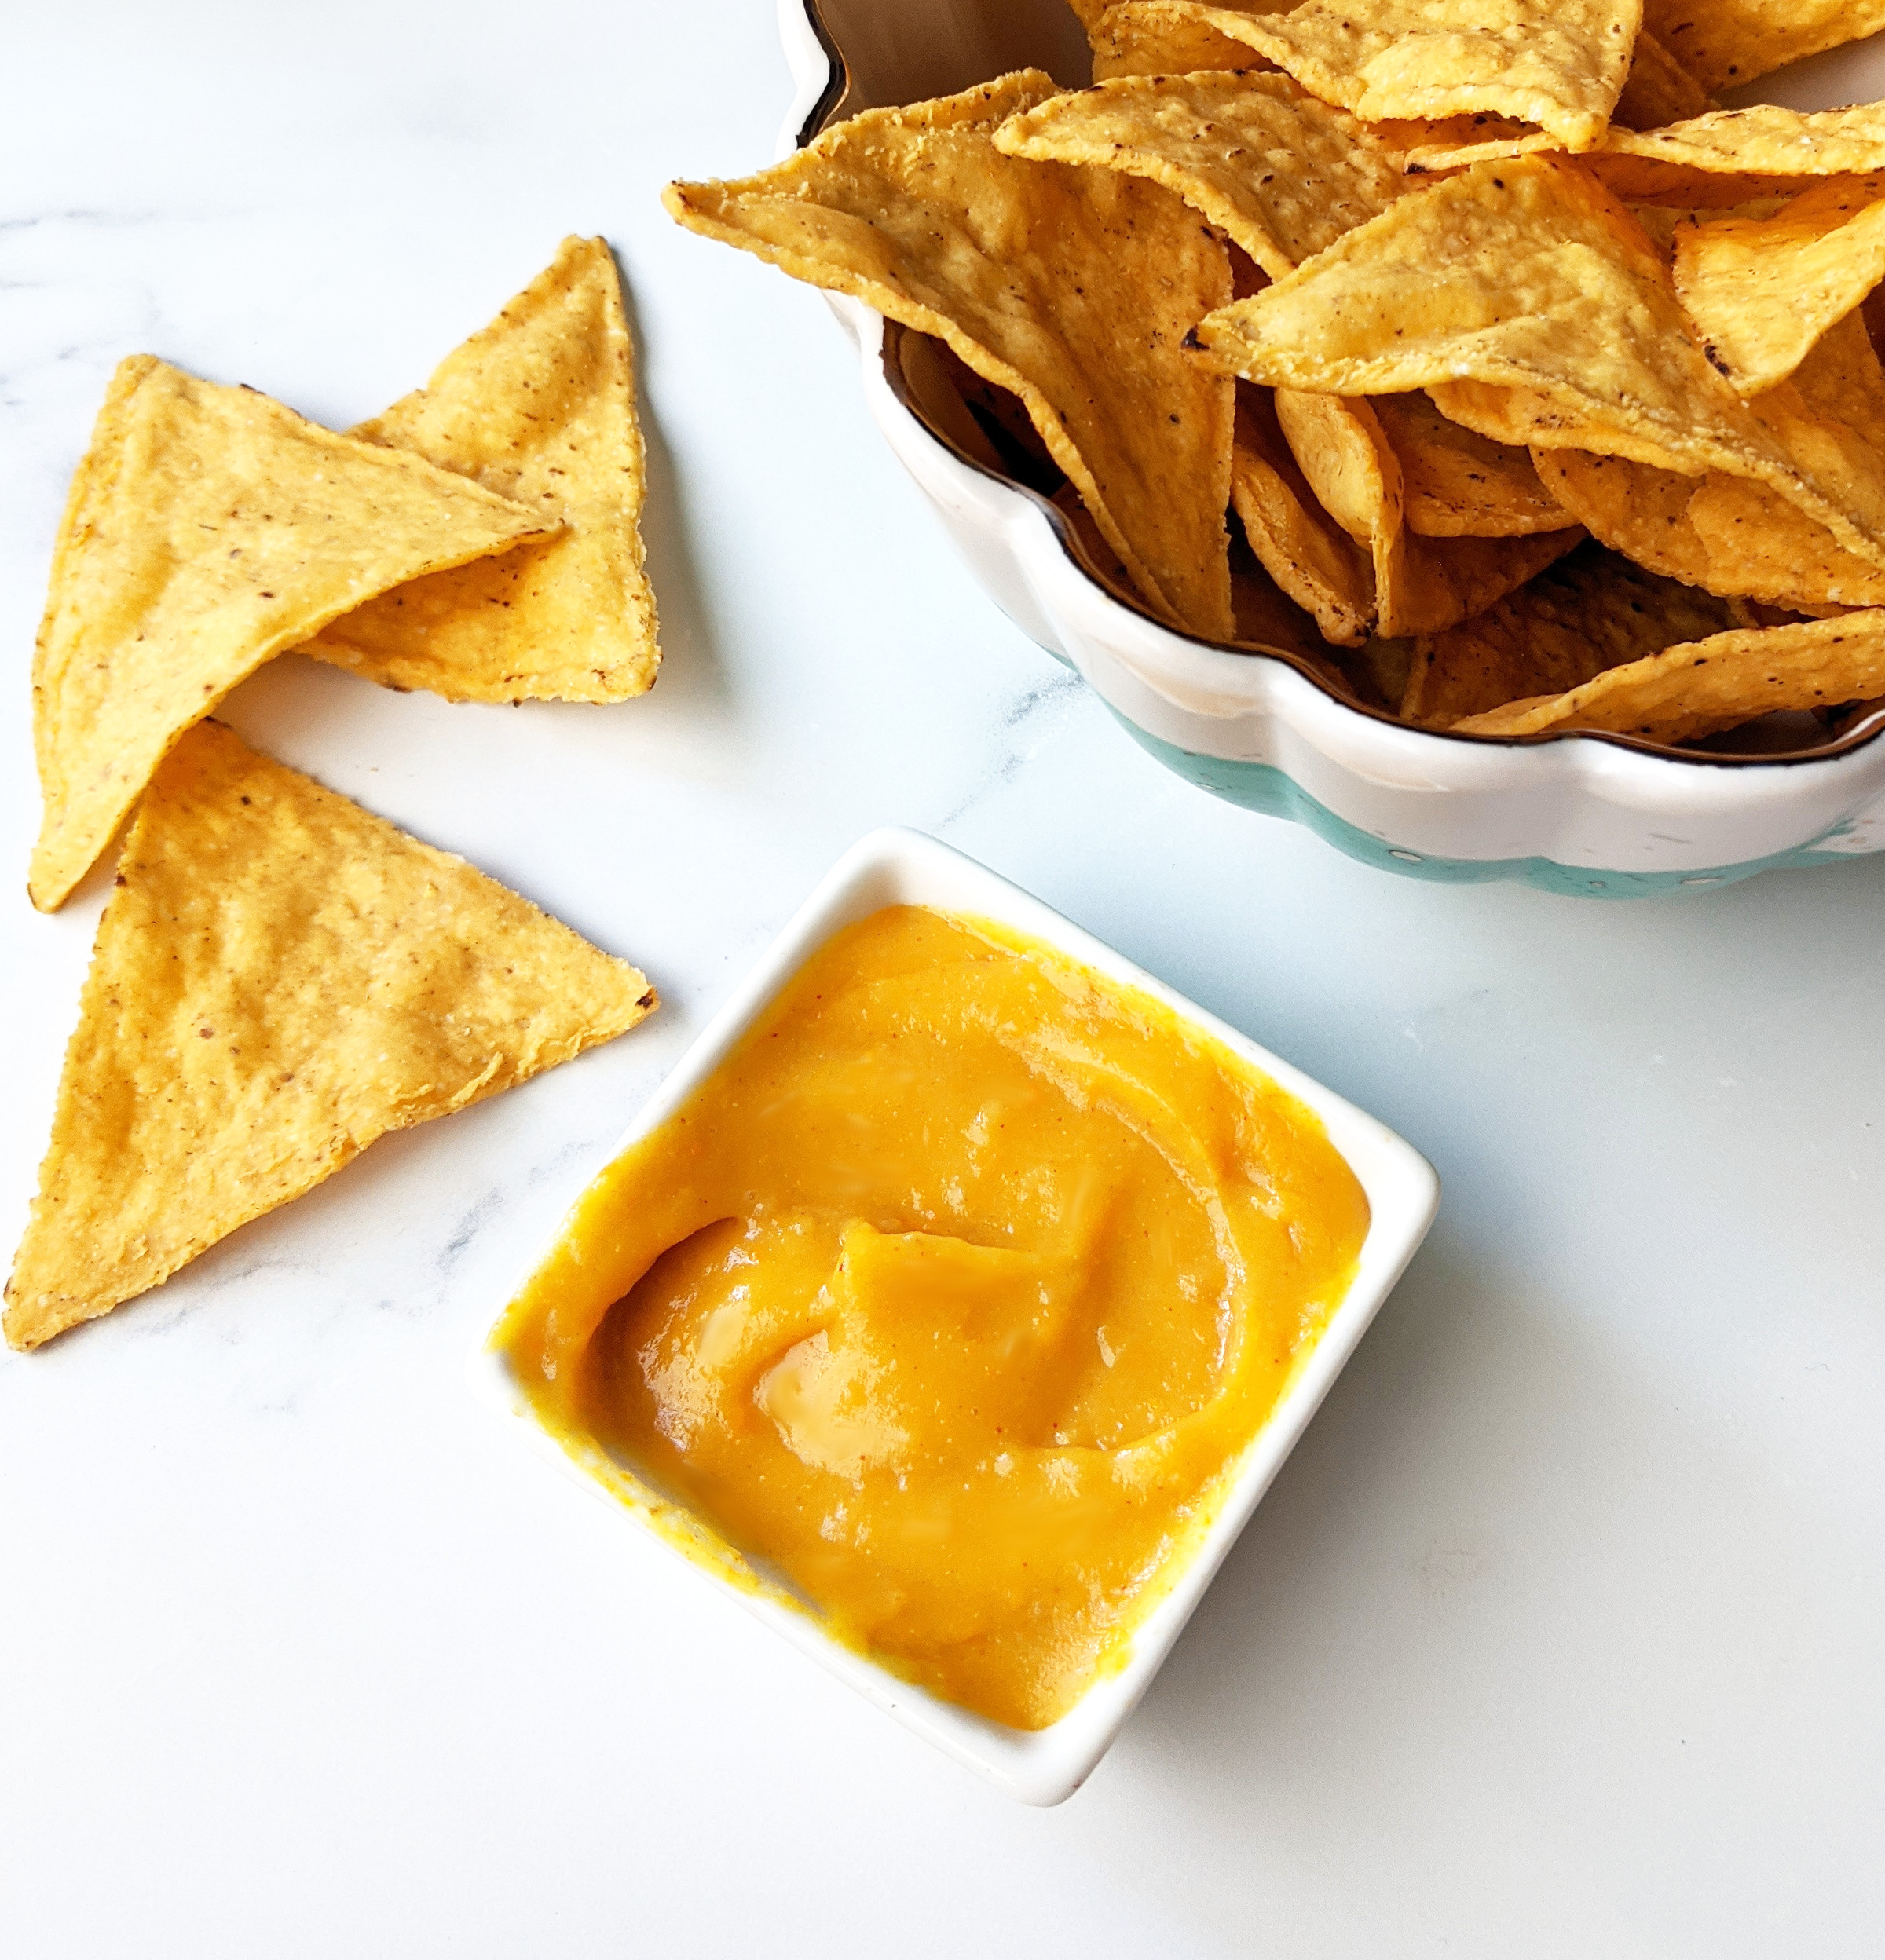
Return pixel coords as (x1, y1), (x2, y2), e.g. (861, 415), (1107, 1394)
(470, 829), (1440, 1803)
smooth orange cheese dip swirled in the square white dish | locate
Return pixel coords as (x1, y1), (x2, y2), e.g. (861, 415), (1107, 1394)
(498, 908), (1367, 1728)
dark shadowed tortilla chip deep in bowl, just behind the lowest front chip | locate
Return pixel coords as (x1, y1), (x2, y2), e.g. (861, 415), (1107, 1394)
(1401, 545), (1736, 730)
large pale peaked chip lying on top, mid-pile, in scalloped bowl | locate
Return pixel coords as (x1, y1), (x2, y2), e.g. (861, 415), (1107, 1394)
(1195, 157), (1885, 566)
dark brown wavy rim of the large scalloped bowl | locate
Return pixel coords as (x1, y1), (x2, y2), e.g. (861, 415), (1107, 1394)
(778, 0), (1885, 774)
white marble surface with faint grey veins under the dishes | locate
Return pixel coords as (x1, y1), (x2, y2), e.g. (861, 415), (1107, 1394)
(0, 0), (1885, 1960)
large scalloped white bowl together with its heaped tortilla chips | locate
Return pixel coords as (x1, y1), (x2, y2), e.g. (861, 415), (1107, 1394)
(668, 0), (1885, 896)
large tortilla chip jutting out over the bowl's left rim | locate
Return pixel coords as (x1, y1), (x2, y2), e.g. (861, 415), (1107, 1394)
(664, 71), (1235, 639)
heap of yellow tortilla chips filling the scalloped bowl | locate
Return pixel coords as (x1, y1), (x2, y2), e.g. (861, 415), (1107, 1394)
(666, 0), (1885, 748)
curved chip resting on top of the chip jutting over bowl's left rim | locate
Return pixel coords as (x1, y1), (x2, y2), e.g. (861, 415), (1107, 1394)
(995, 72), (1407, 278)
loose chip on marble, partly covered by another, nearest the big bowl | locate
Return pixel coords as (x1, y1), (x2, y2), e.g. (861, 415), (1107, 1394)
(300, 237), (661, 702)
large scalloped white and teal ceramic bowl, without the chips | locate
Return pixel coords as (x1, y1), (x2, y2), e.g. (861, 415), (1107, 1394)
(780, 0), (1885, 898)
